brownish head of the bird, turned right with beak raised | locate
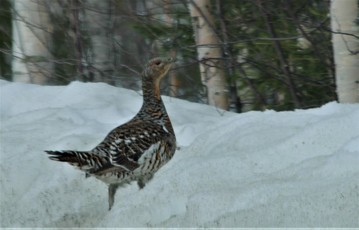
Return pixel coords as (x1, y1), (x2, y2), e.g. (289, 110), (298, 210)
(142, 57), (175, 83)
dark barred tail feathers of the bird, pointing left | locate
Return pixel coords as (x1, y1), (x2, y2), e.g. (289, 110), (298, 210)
(45, 151), (104, 172)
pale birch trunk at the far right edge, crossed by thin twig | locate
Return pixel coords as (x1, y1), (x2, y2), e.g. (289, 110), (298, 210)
(331, 0), (359, 103)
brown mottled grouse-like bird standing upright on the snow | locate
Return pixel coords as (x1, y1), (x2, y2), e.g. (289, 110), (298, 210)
(45, 57), (176, 210)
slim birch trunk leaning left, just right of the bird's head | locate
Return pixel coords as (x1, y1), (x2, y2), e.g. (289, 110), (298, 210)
(188, 0), (229, 110)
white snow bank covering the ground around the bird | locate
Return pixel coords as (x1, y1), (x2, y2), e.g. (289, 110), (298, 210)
(0, 81), (359, 227)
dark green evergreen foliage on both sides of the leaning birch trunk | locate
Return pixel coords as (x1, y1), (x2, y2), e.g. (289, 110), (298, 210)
(134, 0), (336, 110)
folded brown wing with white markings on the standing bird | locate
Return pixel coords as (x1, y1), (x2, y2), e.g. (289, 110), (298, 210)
(94, 121), (171, 171)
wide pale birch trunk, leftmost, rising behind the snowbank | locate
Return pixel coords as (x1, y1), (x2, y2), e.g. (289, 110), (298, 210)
(12, 0), (53, 84)
